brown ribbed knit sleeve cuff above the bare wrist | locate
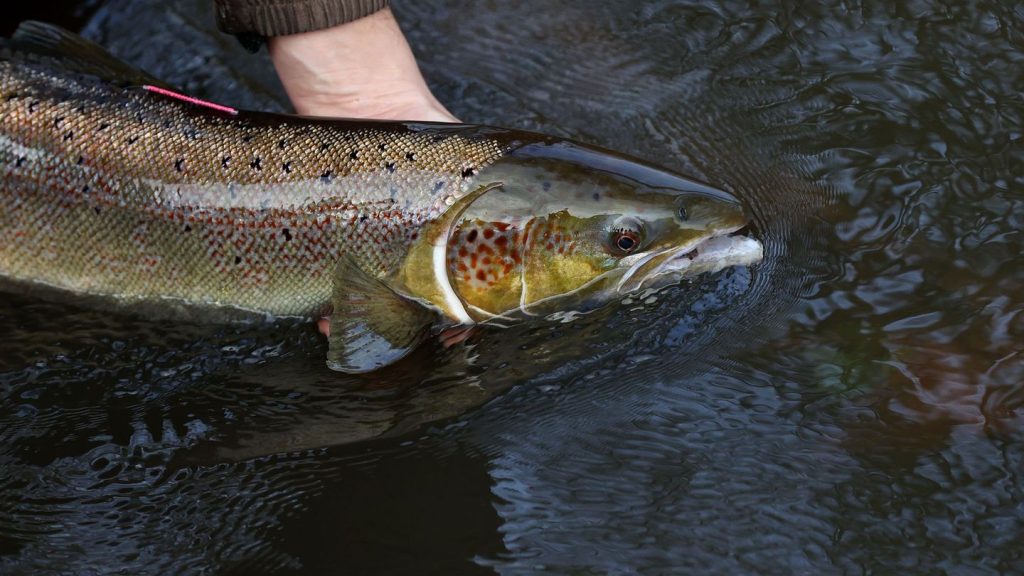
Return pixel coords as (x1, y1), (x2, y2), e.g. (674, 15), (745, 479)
(217, 0), (388, 37)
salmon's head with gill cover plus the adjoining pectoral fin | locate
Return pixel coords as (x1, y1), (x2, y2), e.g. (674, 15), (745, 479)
(328, 135), (762, 372)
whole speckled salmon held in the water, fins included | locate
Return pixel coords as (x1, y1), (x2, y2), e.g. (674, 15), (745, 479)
(0, 24), (761, 372)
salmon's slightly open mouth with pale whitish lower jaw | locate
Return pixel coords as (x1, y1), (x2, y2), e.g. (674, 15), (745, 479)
(616, 228), (764, 292)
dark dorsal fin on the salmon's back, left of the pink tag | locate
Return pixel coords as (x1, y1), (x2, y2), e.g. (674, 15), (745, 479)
(3, 20), (173, 89)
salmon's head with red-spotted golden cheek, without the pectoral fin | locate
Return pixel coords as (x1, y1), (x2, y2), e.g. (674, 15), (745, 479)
(447, 142), (762, 321)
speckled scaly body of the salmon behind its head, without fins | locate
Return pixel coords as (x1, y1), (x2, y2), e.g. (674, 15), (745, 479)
(0, 51), (506, 316)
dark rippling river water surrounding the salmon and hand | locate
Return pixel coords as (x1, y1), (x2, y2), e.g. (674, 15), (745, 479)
(0, 0), (1024, 574)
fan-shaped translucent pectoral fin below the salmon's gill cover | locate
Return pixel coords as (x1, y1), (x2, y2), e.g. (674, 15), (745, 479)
(327, 256), (437, 374)
